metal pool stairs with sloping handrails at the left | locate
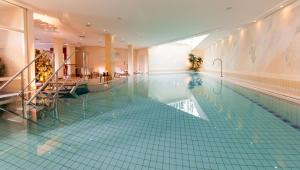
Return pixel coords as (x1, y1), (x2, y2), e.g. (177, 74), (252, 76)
(0, 51), (86, 118)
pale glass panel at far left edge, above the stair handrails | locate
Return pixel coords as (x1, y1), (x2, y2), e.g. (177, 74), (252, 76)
(0, 0), (26, 77)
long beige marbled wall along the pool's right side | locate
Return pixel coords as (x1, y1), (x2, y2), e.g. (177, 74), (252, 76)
(204, 2), (300, 80)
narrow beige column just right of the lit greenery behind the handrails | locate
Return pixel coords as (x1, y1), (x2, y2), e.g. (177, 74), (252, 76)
(53, 39), (64, 77)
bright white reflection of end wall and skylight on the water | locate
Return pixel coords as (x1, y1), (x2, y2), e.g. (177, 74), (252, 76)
(149, 73), (208, 120)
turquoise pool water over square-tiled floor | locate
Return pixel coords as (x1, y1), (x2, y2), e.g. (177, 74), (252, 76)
(0, 73), (300, 170)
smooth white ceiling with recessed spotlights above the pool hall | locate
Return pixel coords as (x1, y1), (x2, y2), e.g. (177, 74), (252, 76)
(13, 0), (285, 48)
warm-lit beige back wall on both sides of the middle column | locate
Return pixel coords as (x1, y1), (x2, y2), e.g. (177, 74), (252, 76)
(76, 46), (128, 72)
